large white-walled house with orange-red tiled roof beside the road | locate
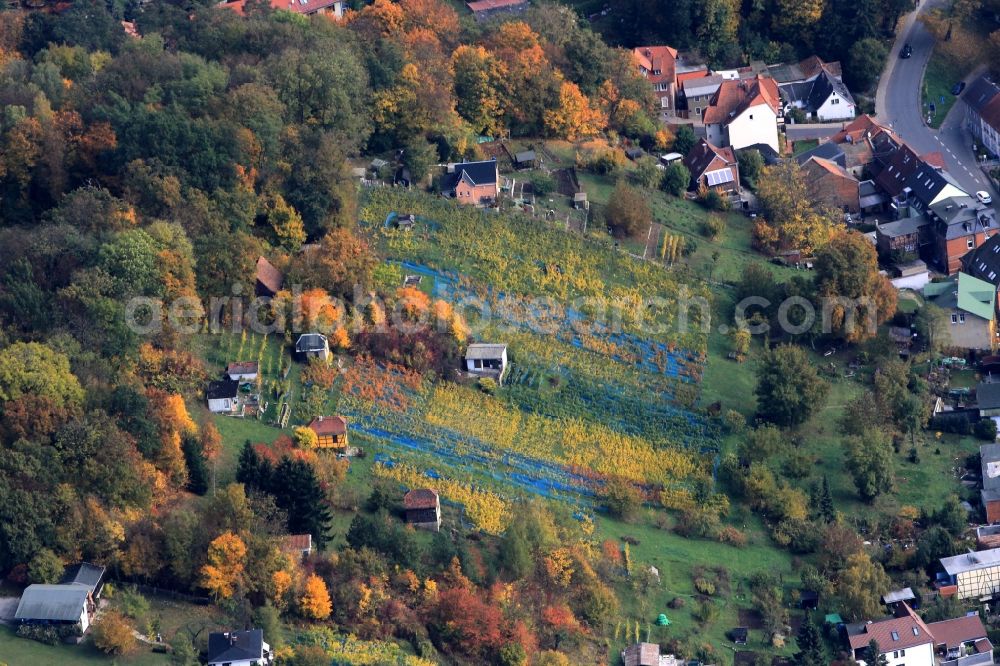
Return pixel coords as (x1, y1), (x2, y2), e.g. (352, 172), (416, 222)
(704, 75), (782, 152)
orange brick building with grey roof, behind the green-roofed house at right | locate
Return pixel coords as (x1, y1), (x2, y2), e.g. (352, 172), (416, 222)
(926, 194), (998, 274)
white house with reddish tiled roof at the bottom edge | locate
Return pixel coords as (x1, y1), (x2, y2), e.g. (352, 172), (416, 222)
(847, 602), (935, 666)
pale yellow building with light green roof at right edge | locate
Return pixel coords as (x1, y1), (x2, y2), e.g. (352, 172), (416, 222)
(924, 273), (997, 350)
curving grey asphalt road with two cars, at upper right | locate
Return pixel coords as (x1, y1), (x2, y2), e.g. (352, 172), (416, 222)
(875, 0), (990, 194)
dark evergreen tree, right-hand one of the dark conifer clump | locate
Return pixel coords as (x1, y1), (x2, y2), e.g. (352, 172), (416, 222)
(272, 456), (330, 548)
